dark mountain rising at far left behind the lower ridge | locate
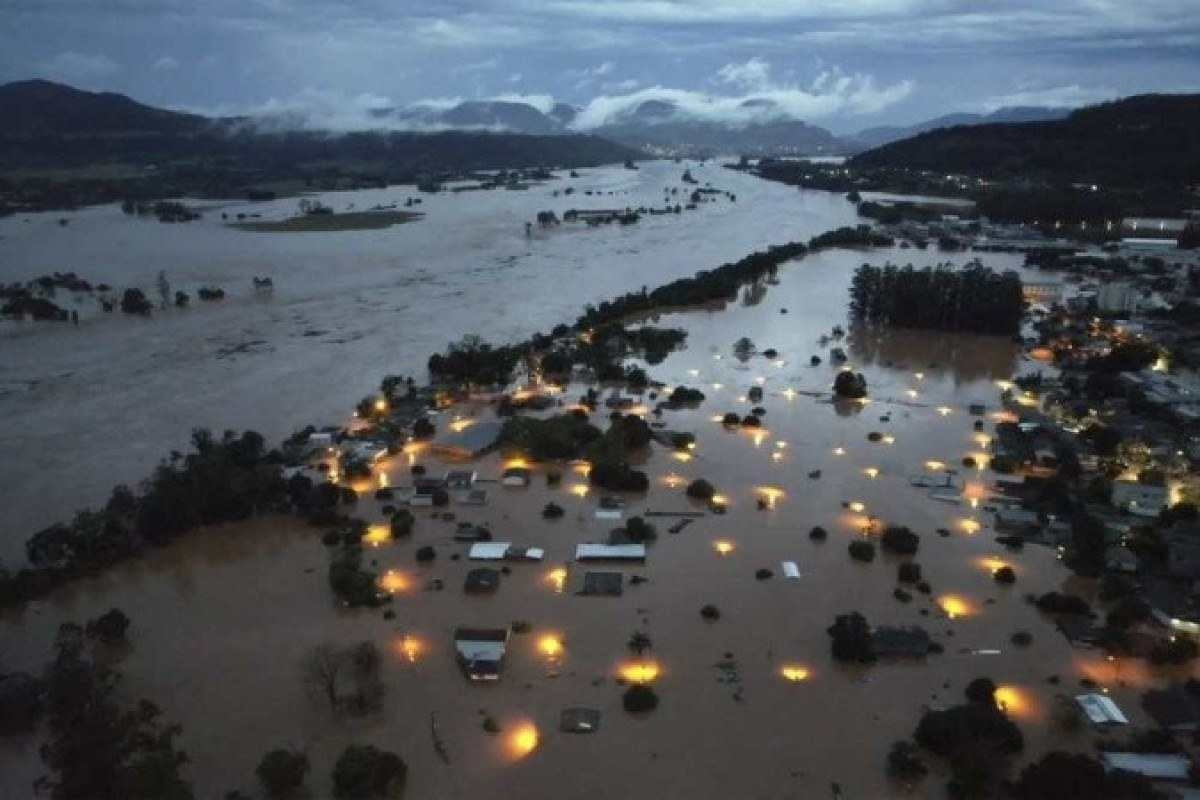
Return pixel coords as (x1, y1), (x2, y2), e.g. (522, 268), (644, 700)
(0, 80), (210, 138)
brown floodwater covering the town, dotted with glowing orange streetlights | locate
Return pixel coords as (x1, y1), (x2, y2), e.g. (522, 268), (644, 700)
(0, 203), (1185, 799)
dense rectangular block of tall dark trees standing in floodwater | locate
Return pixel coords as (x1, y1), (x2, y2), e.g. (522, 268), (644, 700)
(850, 263), (1025, 336)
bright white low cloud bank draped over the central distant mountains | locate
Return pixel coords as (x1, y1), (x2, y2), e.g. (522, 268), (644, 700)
(572, 64), (914, 131)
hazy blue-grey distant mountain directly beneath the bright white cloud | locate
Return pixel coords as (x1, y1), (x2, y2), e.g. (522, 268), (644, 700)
(585, 100), (841, 156)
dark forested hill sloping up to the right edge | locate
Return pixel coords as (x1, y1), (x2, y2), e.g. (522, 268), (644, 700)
(851, 95), (1200, 187)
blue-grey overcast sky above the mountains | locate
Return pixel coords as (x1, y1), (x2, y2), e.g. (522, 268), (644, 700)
(0, 0), (1200, 132)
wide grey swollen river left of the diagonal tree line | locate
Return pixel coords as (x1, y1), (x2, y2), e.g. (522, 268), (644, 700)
(0, 162), (854, 564)
